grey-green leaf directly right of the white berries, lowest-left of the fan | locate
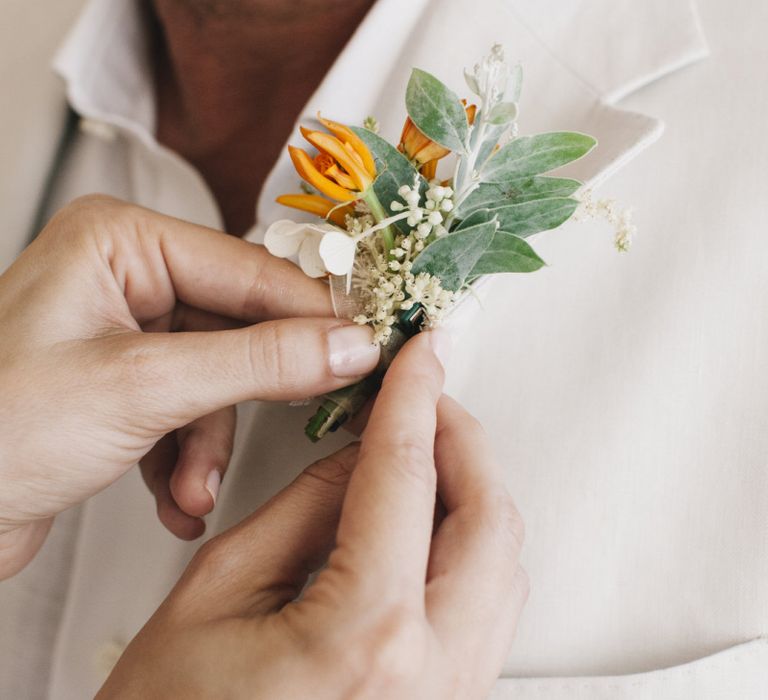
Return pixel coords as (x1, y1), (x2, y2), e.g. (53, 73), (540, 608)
(411, 221), (496, 291)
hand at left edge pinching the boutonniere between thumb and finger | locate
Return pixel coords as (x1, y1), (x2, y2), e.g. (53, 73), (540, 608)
(0, 197), (378, 578)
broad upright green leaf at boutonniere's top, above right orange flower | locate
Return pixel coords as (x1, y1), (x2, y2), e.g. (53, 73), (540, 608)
(405, 68), (469, 151)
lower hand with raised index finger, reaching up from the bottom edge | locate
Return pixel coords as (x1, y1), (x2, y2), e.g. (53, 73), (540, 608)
(97, 333), (528, 700)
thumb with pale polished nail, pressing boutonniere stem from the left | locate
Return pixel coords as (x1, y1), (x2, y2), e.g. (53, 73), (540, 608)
(101, 318), (379, 431)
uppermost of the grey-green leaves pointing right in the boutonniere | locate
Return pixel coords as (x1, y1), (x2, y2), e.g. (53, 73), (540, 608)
(480, 131), (597, 182)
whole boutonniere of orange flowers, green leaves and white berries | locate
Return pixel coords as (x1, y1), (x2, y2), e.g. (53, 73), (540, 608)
(264, 45), (634, 440)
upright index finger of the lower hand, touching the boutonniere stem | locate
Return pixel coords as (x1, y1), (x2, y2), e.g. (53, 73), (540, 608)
(330, 331), (448, 602)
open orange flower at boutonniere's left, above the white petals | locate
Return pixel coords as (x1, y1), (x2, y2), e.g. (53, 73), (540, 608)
(288, 114), (376, 208)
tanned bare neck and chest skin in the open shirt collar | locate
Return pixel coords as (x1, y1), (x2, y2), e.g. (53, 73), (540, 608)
(151, 0), (374, 235)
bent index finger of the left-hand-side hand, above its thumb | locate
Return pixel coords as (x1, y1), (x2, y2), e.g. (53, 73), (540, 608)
(74, 197), (333, 323)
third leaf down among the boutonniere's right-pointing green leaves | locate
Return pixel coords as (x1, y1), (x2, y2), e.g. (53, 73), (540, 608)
(456, 197), (579, 238)
